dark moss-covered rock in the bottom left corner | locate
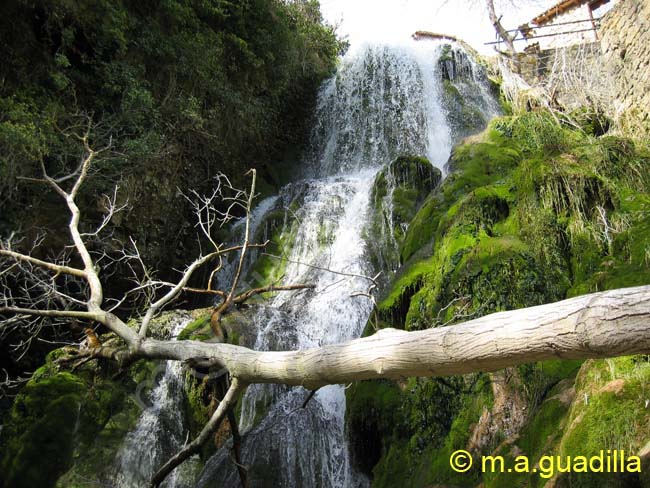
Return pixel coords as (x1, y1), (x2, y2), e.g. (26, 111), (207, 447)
(0, 348), (142, 487)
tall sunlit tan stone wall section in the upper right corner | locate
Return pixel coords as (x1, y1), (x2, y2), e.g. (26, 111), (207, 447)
(600, 0), (650, 137)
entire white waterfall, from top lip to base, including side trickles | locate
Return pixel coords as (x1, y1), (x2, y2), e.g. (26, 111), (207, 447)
(112, 41), (497, 488)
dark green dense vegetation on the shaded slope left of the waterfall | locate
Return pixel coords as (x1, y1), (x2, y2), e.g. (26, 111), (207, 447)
(0, 0), (344, 386)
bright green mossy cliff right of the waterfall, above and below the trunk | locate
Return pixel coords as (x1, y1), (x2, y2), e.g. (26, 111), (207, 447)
(348, 111), (650, 487)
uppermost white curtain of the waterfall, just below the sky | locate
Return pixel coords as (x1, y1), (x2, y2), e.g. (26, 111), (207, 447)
(312, 41), (451, 176)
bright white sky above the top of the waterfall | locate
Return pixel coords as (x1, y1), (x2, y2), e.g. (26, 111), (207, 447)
(320, 0), (558, 54)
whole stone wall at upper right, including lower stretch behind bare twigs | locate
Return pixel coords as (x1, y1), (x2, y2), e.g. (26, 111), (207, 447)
(518, 0), (650, 138)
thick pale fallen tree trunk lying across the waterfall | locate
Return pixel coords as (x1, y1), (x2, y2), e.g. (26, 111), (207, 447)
(141, 286), (650, 389)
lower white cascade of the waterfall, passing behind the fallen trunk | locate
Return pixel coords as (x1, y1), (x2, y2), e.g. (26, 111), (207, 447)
(198, 170), (374, 487)
